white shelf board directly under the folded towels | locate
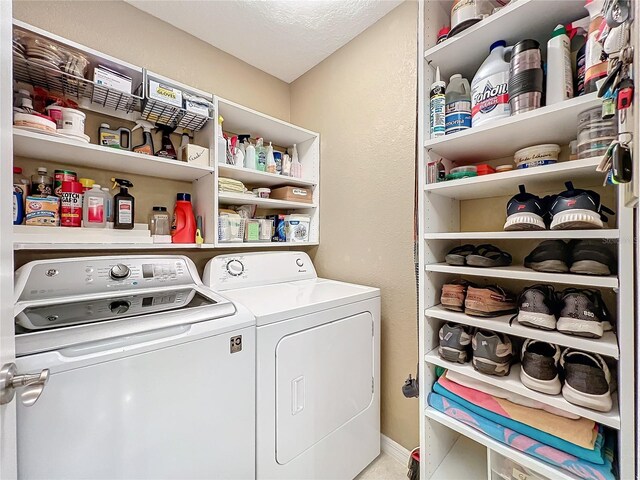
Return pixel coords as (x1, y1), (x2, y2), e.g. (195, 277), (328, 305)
(424, 406), (579, 480)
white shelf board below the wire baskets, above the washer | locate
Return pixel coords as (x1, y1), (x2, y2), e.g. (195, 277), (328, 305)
(13, 129), (214, 181)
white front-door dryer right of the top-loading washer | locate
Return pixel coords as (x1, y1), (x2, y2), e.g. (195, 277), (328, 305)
(203, 252), (380, 480)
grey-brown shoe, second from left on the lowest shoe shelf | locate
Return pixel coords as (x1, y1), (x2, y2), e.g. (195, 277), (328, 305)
(471, 330), (513, 377)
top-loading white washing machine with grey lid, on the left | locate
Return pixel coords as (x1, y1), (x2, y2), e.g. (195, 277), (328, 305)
(15, 256), (255, 480)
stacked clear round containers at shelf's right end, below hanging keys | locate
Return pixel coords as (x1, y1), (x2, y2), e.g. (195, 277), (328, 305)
(578, 107), (618, 158)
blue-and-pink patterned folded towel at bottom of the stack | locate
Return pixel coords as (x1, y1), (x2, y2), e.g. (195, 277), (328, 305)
(428, 392), (615, 480)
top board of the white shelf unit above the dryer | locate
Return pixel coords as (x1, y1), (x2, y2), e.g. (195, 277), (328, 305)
(218, 97), (318, 147)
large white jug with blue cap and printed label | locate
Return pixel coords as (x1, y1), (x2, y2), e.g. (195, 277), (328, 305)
(471, 40), (512, 127)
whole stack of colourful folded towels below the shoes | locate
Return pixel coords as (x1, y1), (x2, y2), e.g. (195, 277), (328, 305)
(429, 372), (615, 480)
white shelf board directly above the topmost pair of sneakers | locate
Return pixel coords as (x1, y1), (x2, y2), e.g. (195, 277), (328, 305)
(424, 158), (604, 200)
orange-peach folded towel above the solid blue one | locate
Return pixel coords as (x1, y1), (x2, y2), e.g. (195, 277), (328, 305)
(434, 372), (598, 452)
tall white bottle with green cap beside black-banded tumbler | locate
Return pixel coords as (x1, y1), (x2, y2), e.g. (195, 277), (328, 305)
(547, 25), (573, 105)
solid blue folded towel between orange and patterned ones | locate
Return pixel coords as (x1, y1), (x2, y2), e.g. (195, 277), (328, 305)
(433, 382), (604, 465)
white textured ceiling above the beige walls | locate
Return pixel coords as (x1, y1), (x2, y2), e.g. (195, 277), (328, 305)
(126, 0), (402, 83)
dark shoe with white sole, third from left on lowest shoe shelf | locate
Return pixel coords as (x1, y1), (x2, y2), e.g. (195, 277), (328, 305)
(520, 340), (562, 395)
